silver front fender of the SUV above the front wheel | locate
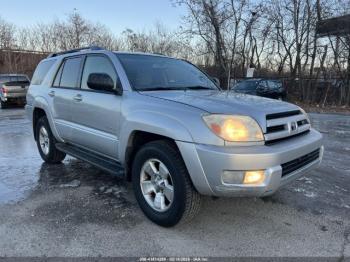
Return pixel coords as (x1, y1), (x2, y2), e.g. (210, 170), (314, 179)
(119, 92), (224, 161)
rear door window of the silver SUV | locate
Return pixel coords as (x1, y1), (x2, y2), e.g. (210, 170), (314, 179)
(54, 57), (82, 88)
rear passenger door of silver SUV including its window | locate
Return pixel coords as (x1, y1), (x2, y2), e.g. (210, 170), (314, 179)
(49, 56), (83, 142)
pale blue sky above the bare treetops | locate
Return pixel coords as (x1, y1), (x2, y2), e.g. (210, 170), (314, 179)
(0, 0), (186, 34)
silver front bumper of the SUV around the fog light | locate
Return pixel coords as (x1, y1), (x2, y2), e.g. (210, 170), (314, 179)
(177, 129), (323, 197)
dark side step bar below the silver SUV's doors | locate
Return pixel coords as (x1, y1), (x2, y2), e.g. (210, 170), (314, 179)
(55, 143), (124, 177)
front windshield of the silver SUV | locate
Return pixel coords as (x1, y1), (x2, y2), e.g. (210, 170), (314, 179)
(117, 54), (218, 91)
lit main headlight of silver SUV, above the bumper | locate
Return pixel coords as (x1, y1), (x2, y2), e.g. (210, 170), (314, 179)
(203, 114), (264, 142)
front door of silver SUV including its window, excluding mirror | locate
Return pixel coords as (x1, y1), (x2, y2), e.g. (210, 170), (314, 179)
(72, 54), (122, 160)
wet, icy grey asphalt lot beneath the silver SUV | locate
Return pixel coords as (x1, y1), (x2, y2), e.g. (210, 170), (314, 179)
(0, 108), (350, 260)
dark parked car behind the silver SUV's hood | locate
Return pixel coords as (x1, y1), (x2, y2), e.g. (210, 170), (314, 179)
(233, 78), (286, 100)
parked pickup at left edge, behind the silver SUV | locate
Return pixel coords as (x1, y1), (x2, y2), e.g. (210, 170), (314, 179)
(0, 74), (29, 108)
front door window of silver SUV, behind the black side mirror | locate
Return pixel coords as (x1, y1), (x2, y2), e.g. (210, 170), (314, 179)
(81, 56), (117, 89)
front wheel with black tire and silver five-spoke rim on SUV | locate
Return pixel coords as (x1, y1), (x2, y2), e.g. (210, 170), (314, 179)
(132, 140), (200, 227)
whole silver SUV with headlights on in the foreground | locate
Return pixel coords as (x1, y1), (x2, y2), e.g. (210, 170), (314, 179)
(26, 48), (323, 227)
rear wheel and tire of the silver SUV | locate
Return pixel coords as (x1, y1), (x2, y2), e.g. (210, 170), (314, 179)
(35, 116), (66, 164)
